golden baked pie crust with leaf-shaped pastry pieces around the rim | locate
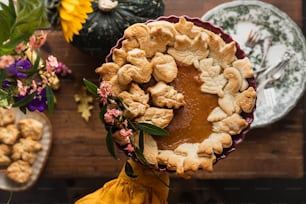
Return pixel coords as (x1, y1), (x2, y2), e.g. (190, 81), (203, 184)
(96, 16), (256, 177)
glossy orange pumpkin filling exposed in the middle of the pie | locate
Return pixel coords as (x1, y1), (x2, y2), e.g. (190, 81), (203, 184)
(154, 66), (218, 150)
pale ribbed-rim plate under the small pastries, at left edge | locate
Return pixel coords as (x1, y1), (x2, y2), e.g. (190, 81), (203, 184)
(0, 108), (52, 191)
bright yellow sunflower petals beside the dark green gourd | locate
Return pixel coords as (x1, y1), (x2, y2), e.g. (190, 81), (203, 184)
(59, 0), (93, 42)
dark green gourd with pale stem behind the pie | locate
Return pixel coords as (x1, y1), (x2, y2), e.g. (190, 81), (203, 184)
(47, 0), (164, 57)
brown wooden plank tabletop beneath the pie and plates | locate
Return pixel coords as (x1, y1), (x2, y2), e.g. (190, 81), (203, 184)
(43, 0), (304, 179)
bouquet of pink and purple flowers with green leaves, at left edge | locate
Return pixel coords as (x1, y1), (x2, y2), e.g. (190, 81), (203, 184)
(0, 0), (71, 113)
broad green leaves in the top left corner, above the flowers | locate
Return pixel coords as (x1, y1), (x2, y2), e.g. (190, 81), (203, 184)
(0, 0), (49, 56)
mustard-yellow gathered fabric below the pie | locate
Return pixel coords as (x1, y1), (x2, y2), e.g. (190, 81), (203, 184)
(75, 160), (169, 204)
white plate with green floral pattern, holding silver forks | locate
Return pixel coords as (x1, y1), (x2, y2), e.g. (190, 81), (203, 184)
(202, 0), (306, 128)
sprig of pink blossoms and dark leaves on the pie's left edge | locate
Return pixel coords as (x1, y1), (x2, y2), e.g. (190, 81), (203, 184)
(84, 79), (168, 177)
